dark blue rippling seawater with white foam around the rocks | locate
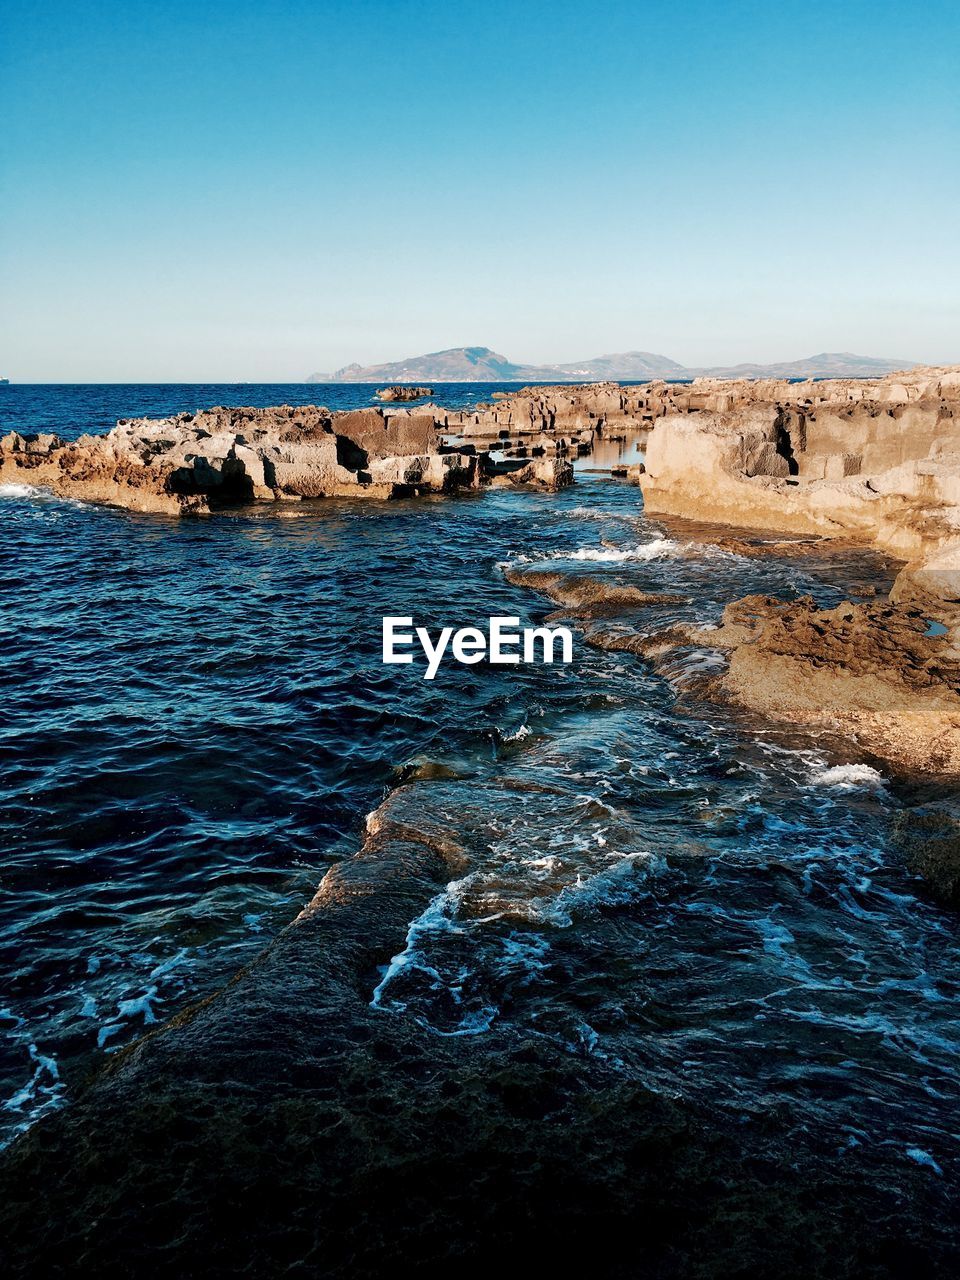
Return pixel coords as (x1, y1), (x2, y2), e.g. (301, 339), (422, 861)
(0, 387), (960, 1179)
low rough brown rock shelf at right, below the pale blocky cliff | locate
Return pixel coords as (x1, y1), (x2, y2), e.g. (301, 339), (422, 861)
(506, 567), (960, 778)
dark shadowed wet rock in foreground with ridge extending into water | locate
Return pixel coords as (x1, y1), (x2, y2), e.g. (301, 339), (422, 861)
(0, 780), (960, 1280)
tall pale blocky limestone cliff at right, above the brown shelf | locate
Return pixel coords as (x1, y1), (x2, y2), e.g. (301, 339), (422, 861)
(640, 367), (960, 614)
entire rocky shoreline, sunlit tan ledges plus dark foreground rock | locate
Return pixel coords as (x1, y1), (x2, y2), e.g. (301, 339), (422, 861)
(0, 371), (960, 1280)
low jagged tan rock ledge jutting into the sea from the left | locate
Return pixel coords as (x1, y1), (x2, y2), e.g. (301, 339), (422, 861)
(0, 404), (572, 516)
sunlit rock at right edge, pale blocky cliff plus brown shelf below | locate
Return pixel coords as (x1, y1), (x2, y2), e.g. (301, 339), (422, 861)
(586, 369), (960, 776)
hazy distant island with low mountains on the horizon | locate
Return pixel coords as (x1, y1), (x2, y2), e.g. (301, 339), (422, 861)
(307, 347), (918, 383)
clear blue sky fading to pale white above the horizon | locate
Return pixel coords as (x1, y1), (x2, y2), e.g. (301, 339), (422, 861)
(0, 0), (960, 381)
